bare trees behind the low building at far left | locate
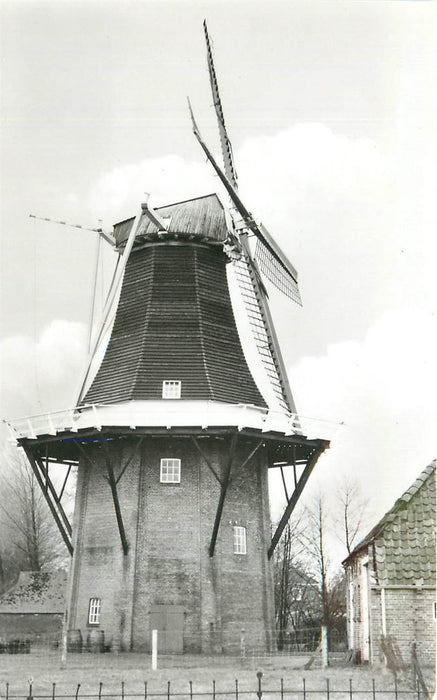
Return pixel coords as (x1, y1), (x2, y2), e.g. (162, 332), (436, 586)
(0, 449), (68, 584)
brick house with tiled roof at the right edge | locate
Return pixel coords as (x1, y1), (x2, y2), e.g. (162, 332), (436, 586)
(343, 460), (436, 665)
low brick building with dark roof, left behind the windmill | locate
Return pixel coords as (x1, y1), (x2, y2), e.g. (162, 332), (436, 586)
(0, 570), (67, 642)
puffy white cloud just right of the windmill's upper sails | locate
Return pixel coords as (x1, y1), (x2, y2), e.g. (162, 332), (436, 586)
(238, 123), (387, 216)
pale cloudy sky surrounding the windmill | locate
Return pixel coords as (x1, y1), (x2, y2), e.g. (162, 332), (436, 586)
(0, 0), (437, 568)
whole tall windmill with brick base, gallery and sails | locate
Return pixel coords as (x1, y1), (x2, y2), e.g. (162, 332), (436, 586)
(6, 24), (329, 653)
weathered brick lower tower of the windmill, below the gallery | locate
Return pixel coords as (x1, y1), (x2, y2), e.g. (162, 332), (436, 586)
(69, 437), (274, 653)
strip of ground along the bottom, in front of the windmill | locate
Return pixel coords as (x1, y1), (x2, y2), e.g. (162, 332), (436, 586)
(0, 654), (432, 700)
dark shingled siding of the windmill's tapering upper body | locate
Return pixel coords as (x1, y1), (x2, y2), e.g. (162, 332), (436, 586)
(84, 243), (266, 406)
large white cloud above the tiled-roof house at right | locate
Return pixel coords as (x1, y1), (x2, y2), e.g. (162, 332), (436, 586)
(290, 309), (437, 514)
